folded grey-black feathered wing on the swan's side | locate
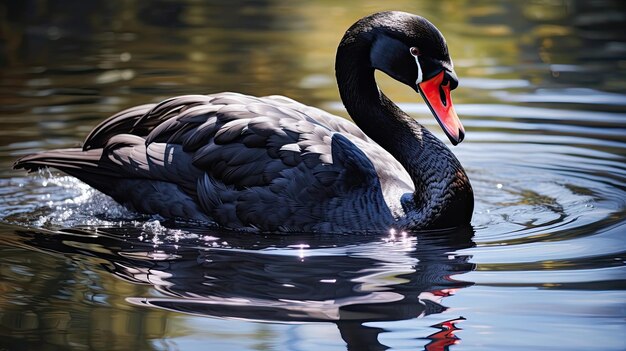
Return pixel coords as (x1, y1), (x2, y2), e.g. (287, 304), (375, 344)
(52, 93), (393, 231)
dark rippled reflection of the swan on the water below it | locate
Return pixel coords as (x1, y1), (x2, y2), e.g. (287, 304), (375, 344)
(11, 224), (475, 349)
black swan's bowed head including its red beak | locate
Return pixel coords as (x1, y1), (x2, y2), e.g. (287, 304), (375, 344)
(364, 11), (465, 145)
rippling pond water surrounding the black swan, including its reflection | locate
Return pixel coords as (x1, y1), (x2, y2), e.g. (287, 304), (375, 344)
(0, 0), (626, 351)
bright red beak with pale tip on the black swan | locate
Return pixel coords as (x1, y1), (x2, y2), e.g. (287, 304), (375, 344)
(418, 71), (465, 145)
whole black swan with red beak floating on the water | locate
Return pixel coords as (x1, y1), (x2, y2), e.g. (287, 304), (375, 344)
(14, 11), (474, 232)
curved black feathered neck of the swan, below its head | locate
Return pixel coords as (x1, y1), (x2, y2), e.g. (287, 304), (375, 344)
(335, 37), (474, 228)
